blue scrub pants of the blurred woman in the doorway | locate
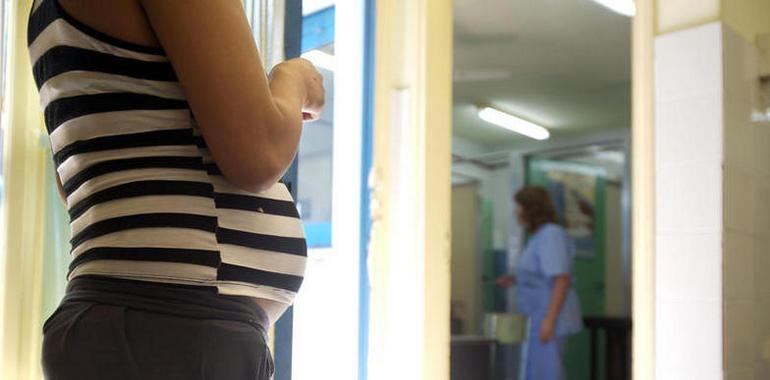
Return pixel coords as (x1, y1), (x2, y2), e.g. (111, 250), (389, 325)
(523, 321), (567, 380)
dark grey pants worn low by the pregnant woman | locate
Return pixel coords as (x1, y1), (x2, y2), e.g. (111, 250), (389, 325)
(43, 279), (273, 380)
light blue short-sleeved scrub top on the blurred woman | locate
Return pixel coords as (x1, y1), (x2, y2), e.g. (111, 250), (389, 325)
(516, 223), (583, 337)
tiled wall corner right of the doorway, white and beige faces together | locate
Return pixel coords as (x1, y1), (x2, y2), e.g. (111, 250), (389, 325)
(655, 23), (770, 380)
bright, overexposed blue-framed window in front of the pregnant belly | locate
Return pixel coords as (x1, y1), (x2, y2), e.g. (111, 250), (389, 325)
(292, 0), (368, 380)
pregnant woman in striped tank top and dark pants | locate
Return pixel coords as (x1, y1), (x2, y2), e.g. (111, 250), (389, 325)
(28, 0), (324, 380)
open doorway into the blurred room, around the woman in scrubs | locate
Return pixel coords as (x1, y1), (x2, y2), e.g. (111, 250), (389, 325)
(451, 0), (632, 379)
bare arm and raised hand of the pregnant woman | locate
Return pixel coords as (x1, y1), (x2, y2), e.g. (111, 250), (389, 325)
(140, 0), (323, 191)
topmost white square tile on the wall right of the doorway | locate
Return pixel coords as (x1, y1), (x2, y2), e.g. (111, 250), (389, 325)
(655, 23), (722, 102)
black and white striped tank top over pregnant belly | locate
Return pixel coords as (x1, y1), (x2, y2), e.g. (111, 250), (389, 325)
(28, 0), (307, 304)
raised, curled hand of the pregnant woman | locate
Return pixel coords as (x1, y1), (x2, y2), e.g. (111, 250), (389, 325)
(270, 58), (326, 121)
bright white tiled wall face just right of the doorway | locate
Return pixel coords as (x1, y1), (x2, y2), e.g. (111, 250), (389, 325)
(652, 23), (724, 380)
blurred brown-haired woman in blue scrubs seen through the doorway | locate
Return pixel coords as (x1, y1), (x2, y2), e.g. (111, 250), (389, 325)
(497, 187), (583, 380)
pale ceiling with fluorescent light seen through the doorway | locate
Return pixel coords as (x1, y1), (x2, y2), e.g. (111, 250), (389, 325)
(454, 0), (631, 149)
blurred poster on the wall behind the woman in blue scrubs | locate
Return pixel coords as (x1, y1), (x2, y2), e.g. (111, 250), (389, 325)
(527, 158), (606, 259)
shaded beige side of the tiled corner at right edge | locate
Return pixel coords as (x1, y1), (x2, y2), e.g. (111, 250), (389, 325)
(723, 24), (770, 380)
